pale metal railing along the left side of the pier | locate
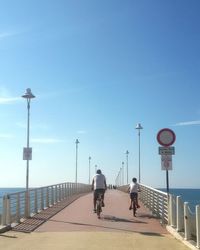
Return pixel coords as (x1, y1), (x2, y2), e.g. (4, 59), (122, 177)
(0, 182), (91, 226)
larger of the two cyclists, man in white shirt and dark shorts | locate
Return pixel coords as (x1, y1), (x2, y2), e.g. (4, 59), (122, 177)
(92, 169), (107, 213)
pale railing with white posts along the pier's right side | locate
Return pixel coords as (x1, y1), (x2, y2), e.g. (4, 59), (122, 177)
(118, 184), (200, 249)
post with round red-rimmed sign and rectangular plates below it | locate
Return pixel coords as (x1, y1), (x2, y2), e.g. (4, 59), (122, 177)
(157, 128), (176, 193)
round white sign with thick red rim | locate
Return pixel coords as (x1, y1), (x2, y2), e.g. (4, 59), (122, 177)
(157, 128), (176, 147)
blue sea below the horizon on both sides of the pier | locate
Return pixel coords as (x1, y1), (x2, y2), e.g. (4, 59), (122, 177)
(0, 188), (200, 214)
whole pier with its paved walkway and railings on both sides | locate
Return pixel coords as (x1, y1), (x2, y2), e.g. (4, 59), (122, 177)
(0, 183), (198, 250)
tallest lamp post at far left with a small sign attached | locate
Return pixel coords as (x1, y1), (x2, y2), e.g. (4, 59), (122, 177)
(22, 88), (35, 217)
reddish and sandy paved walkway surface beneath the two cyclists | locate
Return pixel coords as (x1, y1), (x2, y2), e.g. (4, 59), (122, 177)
(0, 190), (189, 250)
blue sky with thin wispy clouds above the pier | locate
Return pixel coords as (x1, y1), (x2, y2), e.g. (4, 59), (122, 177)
(0, 0), (200, 188)
